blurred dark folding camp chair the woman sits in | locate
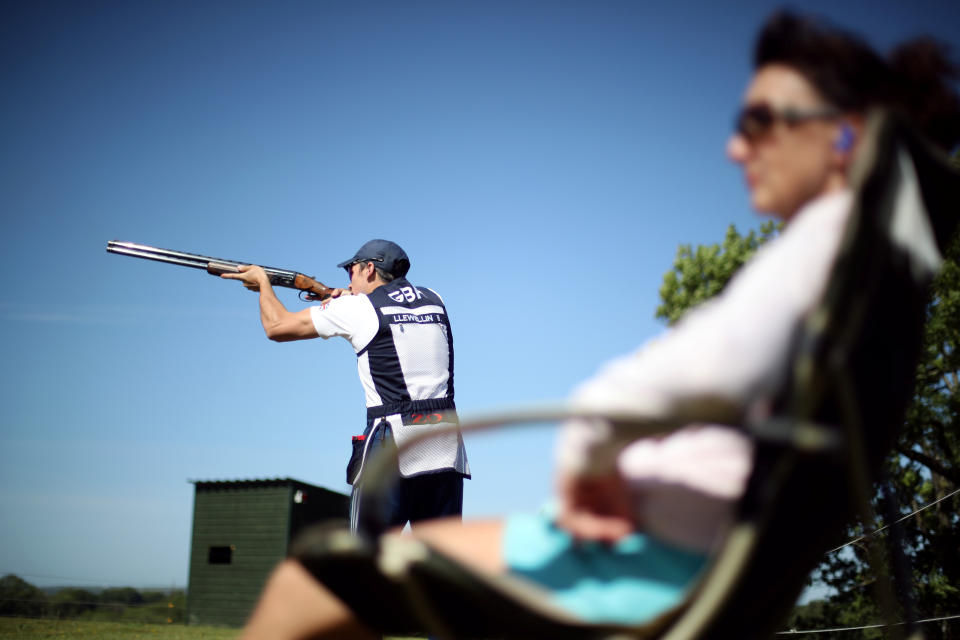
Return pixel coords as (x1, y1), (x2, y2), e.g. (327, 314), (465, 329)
(293, 112), (960, 640)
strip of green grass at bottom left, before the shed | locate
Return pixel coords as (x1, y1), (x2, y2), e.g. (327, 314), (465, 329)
(0, 618), (240, 640)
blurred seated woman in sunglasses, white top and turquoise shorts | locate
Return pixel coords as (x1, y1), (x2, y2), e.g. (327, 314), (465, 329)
(245, 13), (960, 638)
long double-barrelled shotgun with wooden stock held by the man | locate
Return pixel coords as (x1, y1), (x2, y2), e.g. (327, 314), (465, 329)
(107, 240), (333, 300)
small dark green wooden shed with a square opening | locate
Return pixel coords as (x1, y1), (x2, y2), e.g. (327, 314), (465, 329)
(187, 478), (350, 626)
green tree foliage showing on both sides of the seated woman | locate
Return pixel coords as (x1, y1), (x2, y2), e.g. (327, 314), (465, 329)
(656, 174), (960, 638)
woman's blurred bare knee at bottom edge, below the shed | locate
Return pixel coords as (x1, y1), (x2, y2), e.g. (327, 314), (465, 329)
(241, 560), (380, 640)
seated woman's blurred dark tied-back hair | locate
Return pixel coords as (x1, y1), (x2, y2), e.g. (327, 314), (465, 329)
(754, 11), (960, 149)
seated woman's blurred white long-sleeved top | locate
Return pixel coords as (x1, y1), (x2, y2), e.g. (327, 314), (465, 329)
(557, 191), (852, 550)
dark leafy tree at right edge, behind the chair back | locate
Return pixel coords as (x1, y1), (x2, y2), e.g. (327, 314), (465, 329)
(812, 228), (960, 639)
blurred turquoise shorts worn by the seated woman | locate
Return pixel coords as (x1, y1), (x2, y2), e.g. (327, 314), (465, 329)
(503, 510), (706, 624)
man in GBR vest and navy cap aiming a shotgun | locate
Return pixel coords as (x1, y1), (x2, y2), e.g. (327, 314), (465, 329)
(107, 240), (470, 534)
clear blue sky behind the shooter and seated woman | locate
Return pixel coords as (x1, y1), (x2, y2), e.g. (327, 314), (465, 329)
(0, 0), (960, 586)
